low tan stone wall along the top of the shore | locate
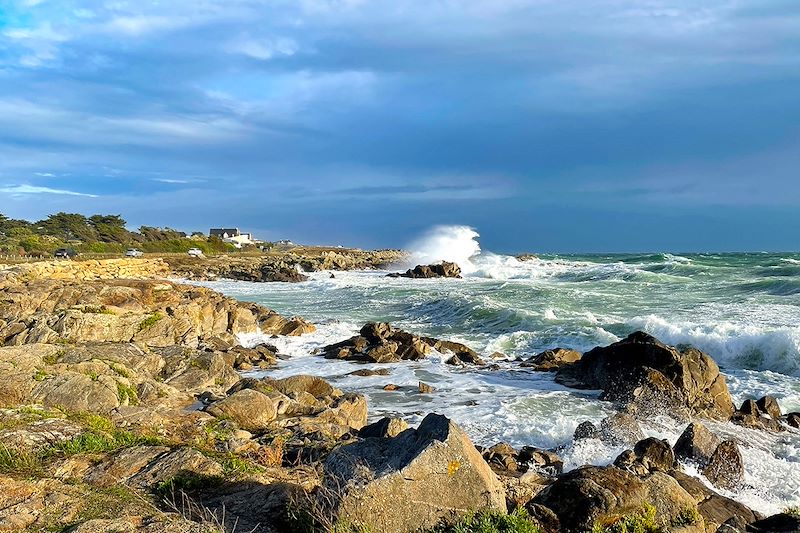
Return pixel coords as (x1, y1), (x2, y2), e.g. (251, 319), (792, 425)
(0, 258), (170, 281)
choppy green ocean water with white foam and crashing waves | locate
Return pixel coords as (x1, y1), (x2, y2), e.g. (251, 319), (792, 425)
(186, 228), (800, 514)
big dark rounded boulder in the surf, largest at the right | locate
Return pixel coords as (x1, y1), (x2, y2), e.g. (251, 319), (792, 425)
(556, 331), (734, 420)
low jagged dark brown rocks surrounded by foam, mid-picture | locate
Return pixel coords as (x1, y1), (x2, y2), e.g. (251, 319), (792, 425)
(319, 322), (483, 364)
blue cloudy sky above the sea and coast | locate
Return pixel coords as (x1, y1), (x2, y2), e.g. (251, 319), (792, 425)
(0, 0), (800, 252)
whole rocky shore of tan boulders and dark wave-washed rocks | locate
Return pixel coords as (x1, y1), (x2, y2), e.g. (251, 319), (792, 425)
(0, 255), (800, 533)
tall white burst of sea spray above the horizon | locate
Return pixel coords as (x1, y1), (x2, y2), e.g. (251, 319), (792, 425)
(407, 226), (481, 274)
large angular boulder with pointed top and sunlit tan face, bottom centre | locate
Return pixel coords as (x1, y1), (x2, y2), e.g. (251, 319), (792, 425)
(318, 414), (506, 533)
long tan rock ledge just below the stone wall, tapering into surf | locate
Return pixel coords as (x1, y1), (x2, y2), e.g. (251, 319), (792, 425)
(0, 280), (315, 347)
